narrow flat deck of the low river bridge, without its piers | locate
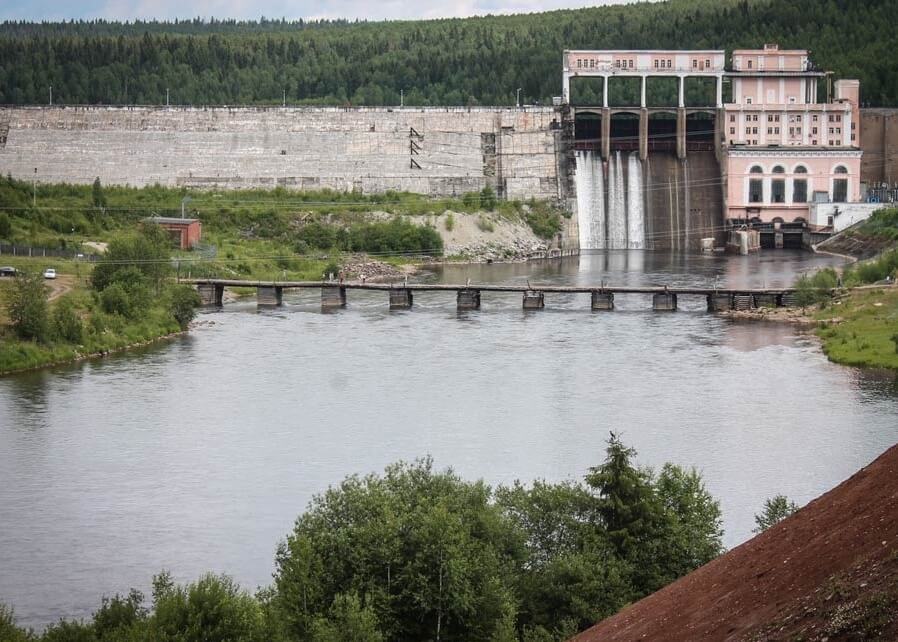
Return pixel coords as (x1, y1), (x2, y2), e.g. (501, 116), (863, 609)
(181, 279), (795, 295)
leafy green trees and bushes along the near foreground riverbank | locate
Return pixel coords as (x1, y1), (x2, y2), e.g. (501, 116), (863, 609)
(0, 435), (721, 642)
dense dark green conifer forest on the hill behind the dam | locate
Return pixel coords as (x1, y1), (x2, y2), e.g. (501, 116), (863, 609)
(0, 0), (898, 105)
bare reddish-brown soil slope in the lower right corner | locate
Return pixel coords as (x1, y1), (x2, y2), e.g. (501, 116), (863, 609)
(574, 446), (898, 642)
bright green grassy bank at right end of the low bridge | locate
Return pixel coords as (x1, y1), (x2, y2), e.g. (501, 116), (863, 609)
(817, 289), (898, 369)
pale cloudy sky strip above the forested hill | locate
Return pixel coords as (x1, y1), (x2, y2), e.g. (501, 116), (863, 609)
(0, 0), (644, 21)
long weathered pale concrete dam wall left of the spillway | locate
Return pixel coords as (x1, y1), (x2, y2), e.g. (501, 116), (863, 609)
(0, 106), (563, 199)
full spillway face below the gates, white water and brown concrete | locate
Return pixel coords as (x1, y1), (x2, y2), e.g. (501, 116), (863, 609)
(574, 151), (723, 250)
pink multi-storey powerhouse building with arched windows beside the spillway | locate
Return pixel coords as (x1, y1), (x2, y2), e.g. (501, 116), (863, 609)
(721, 45), (861, 223)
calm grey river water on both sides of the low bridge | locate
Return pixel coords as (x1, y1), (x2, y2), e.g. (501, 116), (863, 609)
(0, 251), (898, 626)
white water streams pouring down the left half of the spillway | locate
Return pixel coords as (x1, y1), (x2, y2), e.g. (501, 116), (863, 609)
(575, 151), (645, 250)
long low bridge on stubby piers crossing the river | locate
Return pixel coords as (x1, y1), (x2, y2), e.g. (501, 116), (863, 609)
(181, 279), (795, 312)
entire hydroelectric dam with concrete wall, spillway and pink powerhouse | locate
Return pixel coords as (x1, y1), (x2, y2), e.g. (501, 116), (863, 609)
(0, 45), (898, 255)
